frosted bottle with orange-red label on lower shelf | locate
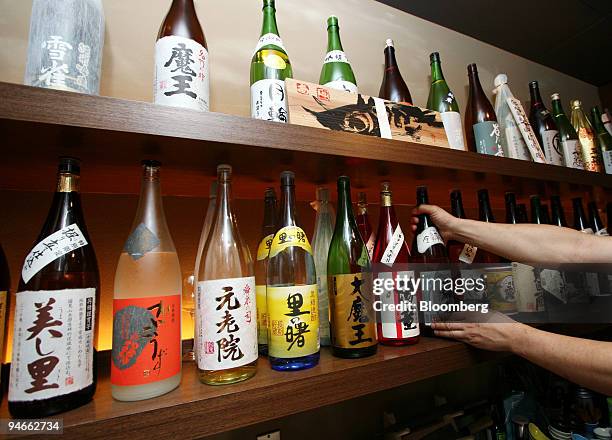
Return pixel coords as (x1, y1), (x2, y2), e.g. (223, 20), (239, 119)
(111, 160), (182, 401)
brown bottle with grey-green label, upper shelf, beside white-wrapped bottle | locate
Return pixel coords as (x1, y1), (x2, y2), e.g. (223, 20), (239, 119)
(465, 64), (504, 156)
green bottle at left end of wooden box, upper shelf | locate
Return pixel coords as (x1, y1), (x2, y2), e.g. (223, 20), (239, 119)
(251, 0), (293, 122)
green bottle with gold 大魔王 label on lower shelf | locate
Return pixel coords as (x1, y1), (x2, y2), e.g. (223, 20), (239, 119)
(327, 176), (376, 358)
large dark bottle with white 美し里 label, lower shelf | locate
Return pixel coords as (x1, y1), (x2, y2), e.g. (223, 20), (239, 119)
(8, 157), (100, 418)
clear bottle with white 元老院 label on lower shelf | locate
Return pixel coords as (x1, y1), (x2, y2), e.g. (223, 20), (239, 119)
(196, 165), (257, 385)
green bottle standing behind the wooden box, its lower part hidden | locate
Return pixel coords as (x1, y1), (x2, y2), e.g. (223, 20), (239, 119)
(319, 15), (357, 93)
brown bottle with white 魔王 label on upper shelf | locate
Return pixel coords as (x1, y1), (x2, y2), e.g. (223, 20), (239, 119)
(154, 0), (210, 112)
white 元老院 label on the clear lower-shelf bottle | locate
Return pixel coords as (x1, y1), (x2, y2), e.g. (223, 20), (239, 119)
(196, 277), (257, 371)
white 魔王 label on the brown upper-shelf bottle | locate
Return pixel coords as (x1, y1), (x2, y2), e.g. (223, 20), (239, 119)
(153, 35), (210, 111)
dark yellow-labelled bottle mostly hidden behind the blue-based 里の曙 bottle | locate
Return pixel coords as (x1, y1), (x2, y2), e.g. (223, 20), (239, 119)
(255, 188), (276, 355)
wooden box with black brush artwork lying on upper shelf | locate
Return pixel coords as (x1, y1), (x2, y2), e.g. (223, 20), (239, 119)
(285, 79), (450, 148)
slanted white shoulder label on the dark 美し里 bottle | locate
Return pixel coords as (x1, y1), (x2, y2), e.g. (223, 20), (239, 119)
(21, 223), (87, 283)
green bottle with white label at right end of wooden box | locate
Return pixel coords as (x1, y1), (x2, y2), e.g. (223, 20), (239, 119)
(427, 52), (465, 150)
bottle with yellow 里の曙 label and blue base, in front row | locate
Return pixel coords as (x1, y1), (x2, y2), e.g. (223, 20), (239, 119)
(266, 171), (320, 371)
